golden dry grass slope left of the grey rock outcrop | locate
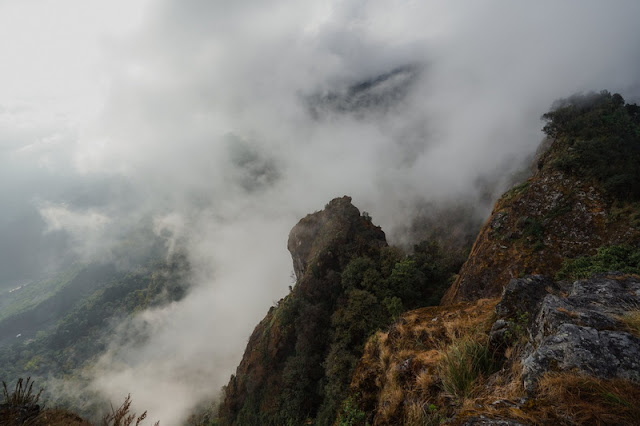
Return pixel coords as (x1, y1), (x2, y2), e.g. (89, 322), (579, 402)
(352, 299), (497, 424)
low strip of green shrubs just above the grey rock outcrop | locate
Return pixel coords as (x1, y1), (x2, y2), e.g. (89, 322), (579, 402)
(556, 244), (640, 280)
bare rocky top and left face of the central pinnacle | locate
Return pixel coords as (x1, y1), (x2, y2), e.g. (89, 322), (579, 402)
(219, 197), (387, 425)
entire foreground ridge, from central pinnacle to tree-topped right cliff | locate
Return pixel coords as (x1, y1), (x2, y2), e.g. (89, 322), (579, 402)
(219, 92), (640, 425)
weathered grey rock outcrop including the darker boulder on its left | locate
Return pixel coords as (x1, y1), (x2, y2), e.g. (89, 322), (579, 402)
(490, 273), (640, 392)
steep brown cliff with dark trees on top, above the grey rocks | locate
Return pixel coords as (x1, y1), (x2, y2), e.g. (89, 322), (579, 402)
(443, 92), (640, 304)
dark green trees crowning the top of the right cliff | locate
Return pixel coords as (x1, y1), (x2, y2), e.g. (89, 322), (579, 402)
(542, 91), (640, 200)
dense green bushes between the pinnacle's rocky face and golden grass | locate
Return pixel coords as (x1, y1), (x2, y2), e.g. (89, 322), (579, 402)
(317, 242), (460, 424)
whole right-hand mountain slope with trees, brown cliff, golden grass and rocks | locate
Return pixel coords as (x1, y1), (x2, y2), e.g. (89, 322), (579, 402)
(341, 92), (640, 426)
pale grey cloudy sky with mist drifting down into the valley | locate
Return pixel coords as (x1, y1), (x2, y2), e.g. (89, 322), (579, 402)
(0, 0), (640, 424)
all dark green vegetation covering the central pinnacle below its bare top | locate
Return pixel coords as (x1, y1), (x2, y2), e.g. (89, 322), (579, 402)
(220, 236), (460, 425)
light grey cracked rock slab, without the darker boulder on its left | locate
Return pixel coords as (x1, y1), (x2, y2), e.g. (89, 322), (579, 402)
(516, 273), (640, 391)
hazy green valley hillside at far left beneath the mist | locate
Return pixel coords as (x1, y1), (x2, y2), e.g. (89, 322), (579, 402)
(0, 256), (189, 418)
